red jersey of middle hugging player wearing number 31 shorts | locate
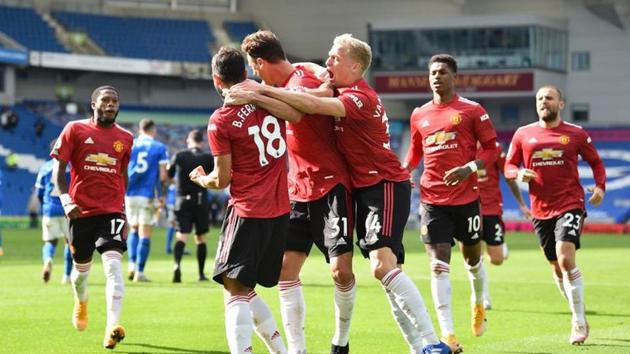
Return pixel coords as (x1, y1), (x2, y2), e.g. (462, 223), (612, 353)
(283, 65), (351, 202)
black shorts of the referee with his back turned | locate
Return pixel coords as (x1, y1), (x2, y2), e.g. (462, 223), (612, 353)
(175, 193), (210, 235)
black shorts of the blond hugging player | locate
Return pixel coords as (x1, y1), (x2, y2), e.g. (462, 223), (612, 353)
(352, 181), (411, 264)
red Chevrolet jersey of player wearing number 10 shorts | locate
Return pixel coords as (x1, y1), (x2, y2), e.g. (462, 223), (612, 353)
(405, 95), (497, 205)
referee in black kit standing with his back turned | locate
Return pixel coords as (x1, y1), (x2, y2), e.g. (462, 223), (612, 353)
(168, 129), (214, 283)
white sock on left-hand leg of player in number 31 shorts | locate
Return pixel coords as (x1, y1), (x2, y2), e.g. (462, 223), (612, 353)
(278, 279), (306, 353)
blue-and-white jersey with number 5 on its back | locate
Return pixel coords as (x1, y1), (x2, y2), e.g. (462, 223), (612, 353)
(127, 135), (168, 198)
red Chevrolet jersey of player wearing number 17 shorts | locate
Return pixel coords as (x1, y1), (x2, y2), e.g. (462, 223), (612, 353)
(50, 118), (133, 217)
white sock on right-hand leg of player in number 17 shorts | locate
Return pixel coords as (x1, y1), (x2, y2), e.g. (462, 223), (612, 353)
(101, 251), (125, 330)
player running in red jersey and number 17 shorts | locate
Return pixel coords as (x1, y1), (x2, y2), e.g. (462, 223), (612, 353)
(50, 86), (133, 349)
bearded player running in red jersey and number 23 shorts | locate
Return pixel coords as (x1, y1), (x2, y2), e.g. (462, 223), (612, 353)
(505, 85), (606, 344)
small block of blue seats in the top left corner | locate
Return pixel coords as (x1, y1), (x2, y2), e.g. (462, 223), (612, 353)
(0, 6), (67, 53)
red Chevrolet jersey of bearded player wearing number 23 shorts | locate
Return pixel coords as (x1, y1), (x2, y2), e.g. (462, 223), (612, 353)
(505, 121), (606, 219)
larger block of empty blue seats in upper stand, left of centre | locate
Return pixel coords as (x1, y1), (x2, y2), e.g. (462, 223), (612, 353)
(53, 11), (215, 62)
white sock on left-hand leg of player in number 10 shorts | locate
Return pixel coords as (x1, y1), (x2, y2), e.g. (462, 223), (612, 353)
(431, 260), (455, 336)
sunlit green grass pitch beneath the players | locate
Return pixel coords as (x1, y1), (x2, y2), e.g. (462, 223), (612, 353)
(0, 229), (630, 354)
